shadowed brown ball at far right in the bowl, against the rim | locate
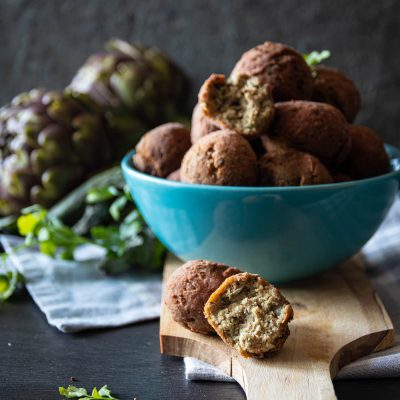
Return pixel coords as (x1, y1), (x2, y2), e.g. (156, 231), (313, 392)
(342, 125), (390, 179)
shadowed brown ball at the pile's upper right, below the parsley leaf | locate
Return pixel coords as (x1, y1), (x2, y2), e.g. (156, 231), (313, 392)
(311, 65), (361, 122)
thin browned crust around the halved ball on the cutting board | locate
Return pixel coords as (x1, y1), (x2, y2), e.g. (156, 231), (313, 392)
(204, 272), (293, 358)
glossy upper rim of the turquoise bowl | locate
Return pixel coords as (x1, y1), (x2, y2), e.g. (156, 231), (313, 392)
(121, 143), (400, 193)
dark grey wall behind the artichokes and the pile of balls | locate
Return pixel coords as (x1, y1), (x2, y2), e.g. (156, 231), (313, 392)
(0, 0), (400, 144)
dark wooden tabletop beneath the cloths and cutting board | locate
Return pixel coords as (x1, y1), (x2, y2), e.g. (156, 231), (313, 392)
(0, 292), (400, 400)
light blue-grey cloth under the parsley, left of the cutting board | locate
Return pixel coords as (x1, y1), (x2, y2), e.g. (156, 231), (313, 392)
(0, 235), (161, 332)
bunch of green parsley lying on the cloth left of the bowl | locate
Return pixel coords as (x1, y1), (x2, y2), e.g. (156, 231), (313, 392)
(0, 180), (165, 301)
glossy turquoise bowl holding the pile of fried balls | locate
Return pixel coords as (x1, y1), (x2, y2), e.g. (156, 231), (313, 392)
(122, 145), (400, 283)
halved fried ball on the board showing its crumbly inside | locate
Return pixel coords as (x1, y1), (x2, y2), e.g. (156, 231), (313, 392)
(204, 272), (293, 358)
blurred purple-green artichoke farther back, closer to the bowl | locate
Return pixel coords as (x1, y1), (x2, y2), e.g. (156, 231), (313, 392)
(66, 39), (188, 155)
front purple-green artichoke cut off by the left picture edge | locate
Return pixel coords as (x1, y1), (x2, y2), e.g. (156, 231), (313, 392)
(0, 90), (113, 215)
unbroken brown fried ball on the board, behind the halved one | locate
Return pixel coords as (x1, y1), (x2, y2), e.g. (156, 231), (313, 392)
(164, 260), (240, 334)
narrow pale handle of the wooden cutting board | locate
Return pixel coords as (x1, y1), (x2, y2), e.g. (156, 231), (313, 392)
(232, 358), (336, 400)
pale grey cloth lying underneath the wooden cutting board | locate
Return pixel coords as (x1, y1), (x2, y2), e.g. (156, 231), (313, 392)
(185, 199), (400, 382)
